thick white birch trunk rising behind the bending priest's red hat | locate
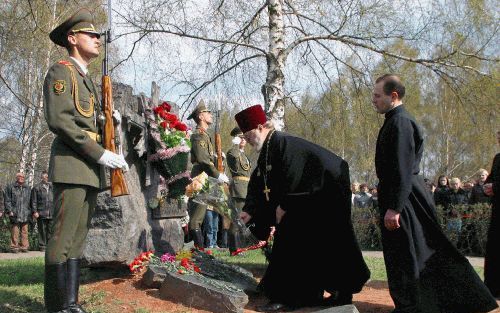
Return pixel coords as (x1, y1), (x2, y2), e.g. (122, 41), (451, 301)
(262, 0), (286, 130)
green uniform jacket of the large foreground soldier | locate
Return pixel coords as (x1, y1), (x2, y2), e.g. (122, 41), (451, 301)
(43, 59), (104, 188)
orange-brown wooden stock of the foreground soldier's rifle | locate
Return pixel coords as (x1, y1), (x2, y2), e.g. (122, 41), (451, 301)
(102, 75), (129, 197)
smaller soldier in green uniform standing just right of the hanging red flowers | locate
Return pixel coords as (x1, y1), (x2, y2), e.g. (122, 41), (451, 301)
(187, 100), (229, 248)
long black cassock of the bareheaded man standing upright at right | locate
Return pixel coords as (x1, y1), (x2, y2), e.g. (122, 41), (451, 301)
(375, 106), (497, 313)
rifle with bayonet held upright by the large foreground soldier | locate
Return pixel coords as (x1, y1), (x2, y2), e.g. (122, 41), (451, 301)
(102, 0), (129, 197)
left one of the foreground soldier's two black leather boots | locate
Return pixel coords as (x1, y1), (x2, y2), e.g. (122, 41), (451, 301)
(43, 262), (70, 313)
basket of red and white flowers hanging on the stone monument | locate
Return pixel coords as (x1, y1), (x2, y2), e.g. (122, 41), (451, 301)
(148, 102), (191, 198)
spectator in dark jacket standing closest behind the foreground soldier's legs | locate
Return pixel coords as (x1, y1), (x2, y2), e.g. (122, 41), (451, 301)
(31, 171), (54, 251)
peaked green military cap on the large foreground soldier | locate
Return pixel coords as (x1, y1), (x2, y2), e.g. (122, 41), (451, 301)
(49, 9), (101, 47)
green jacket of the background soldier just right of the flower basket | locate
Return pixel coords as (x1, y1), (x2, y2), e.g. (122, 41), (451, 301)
(190, 127), (220, 178)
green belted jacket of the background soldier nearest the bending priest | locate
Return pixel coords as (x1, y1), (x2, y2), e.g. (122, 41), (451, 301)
(226, 145), (252, 199)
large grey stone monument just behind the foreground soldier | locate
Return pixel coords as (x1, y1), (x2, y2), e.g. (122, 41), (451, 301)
(83, 84), (185, 267)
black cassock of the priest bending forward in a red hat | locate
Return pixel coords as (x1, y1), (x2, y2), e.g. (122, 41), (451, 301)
(243, 131), (370, 306)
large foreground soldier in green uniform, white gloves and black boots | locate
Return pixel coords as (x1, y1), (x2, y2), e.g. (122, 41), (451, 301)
(43, 9), (128, 313)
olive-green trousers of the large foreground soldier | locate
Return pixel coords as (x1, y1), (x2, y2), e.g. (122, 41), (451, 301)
(45, 183), (99, 264)
